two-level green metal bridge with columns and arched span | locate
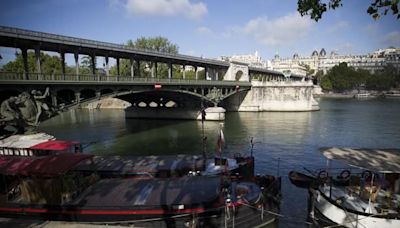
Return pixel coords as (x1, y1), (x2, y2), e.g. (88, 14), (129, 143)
(0, 26), (316, 121)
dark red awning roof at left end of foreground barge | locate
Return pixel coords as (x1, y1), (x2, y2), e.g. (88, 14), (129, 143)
(0, 153), (93, 177)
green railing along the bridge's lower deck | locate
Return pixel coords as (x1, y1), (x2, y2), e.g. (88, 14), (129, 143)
(0, 72), (251, 86)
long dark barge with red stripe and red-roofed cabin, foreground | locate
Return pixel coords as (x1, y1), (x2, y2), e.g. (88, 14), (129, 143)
(0, 153), (281, 227)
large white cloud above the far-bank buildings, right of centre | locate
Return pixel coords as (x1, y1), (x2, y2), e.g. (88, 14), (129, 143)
(229, 12), (314, 47)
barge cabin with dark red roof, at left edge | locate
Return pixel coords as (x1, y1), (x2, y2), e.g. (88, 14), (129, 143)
(0, 153), (96, 206)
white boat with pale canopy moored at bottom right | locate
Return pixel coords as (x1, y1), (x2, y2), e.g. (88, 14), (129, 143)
(309, 148), (400, 228)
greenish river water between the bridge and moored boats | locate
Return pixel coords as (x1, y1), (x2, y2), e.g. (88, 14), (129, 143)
(39, 98), (400, 227)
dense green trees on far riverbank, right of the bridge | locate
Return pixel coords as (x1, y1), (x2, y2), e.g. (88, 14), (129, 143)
(316, 63), (400, 92)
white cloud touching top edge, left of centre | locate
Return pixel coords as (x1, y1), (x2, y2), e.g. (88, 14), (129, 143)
(125, 0), (207, 19)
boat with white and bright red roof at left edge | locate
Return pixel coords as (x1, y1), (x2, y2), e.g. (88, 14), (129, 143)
(0, 133), (82, 156)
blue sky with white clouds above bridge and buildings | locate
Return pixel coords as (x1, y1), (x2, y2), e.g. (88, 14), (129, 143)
(0, 0), (400, 65)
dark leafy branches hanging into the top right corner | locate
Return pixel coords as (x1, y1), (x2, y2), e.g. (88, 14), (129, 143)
(297, 0), (400, 21)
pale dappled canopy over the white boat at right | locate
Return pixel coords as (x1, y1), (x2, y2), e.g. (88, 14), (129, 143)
(321, 147), (400, 173)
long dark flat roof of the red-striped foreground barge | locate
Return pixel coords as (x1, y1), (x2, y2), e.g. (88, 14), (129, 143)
(72, 176), (221, 209)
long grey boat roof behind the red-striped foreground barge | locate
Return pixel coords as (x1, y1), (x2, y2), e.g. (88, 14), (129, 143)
(74, 154), (204, 175)
